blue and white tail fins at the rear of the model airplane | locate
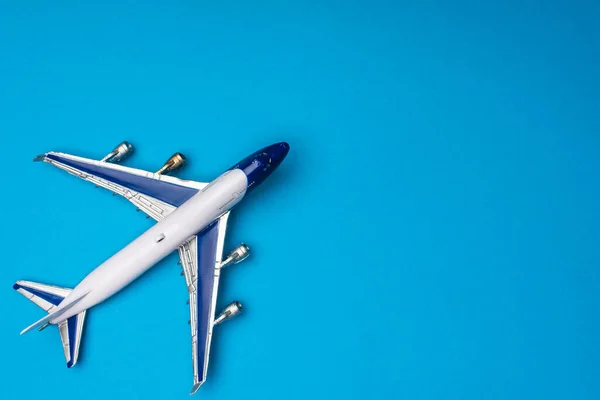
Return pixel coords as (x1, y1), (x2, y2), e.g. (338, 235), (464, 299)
(13, 281), (87, 368)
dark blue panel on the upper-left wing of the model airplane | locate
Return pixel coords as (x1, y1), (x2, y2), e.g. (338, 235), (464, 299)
(46, 154), (198, 207)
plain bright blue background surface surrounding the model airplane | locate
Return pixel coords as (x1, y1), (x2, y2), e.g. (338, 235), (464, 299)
(0, 0), (600, 400)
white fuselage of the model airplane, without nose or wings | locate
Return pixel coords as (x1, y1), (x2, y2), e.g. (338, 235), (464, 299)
(51, 169), (247, 324)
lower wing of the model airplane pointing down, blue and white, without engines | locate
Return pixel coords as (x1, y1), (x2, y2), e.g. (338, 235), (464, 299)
(179, 212), (229, 394)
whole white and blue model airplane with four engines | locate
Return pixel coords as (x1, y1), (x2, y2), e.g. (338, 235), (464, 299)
(14, 142), (289, 394)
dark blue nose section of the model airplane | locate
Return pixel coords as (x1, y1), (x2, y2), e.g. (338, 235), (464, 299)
(233, 142), (290, 191)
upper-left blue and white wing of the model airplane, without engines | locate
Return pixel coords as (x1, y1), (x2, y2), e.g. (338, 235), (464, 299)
(34, 152), (207, 221)
